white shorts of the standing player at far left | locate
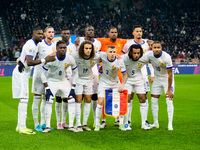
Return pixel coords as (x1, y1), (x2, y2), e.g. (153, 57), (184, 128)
(12, 66), (30, 99)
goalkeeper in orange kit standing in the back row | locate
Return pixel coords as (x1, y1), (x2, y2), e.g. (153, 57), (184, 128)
(97, 27), (127, 128)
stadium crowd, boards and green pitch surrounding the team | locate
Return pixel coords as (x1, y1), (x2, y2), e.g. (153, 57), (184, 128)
(0, 0), (200, 150)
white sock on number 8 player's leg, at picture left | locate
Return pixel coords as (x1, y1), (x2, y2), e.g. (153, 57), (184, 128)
(45, 99), (53, 128)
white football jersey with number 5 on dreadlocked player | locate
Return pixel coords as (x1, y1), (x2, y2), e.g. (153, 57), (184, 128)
(121, 54), (145, 84)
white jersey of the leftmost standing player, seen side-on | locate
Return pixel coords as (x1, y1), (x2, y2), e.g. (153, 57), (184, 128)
(20, 39), (38, 73)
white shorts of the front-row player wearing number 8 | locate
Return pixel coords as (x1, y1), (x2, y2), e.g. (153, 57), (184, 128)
(48, 79), (71, 98)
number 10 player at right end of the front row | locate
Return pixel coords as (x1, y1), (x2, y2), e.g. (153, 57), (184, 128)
(144, 41), (174, 130)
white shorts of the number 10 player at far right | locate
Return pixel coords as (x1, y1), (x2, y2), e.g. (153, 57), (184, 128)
(151, 77), (175, 95)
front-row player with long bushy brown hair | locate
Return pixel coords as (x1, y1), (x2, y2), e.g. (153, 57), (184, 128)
(72, 41), (99, 131)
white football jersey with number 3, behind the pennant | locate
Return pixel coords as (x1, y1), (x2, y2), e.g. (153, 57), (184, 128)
(100, 52), (126, 85)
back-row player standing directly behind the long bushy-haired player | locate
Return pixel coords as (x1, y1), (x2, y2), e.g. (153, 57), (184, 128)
(76, 26), (101, 125)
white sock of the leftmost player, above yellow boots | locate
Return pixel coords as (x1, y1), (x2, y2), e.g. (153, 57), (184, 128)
(17, 99), (28, 129)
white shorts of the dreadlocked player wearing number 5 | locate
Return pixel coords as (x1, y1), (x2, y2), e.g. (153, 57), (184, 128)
(124, 83), (146, 94)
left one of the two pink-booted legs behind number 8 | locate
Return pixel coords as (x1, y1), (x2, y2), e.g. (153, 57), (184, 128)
(55, 95), (63, 130)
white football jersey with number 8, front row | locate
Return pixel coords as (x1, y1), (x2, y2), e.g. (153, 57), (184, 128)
(43, 54), (77, 82)
